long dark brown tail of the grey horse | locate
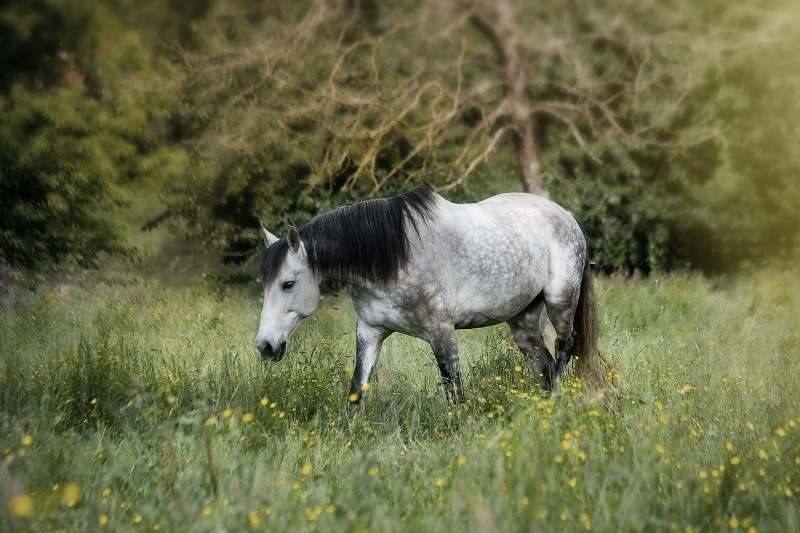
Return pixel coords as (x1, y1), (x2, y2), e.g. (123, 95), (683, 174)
(574, 258), (608, 388)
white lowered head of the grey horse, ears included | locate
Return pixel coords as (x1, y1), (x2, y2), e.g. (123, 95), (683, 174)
(256, 224), (320, 361)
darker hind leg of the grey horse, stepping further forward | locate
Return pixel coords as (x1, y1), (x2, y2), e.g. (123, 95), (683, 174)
(508, 294), (555, 392)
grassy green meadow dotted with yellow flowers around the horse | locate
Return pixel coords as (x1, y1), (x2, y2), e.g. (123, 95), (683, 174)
(0, 270), (800, 531)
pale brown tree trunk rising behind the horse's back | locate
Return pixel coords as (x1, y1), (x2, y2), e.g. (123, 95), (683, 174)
(473, 0), (548, 196)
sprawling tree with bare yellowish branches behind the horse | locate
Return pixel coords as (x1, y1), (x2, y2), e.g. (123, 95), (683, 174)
(164, 0), (768, 269)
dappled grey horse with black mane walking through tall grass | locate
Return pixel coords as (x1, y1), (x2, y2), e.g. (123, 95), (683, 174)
(256, 186), (604, 413)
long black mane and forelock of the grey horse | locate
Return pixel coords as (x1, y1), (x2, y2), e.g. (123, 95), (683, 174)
(263, 185), (436, 285)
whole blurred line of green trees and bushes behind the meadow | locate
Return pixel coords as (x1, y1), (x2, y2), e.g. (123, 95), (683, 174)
(0, 0), (800, 272)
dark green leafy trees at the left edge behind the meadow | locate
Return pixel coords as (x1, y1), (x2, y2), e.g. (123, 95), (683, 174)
(0, 1), (189, 268)
